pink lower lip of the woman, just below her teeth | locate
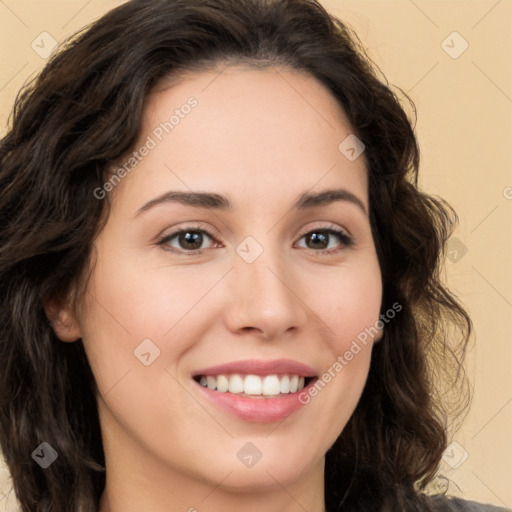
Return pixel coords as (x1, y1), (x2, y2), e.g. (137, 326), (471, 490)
(194, 379), (316, 423)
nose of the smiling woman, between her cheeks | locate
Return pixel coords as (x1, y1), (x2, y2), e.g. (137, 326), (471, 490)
(225, 245), (308, 340)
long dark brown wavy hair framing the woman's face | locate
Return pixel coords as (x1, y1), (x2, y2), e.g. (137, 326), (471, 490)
(0, 0), (472, 512)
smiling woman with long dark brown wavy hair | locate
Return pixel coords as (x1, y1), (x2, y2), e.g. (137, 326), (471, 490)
(0, 0), (508, 512)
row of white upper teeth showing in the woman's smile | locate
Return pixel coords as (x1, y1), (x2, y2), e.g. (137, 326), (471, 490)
(199, 373), (305, 396)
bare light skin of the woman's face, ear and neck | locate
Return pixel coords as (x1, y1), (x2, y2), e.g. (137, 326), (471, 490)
(47, 65), (382, 512)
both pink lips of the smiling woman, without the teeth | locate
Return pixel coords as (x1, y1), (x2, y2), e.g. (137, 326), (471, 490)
(193, 359), (317, 423)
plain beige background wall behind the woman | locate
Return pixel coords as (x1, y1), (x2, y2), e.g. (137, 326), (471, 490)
(0, 0), (512, 511)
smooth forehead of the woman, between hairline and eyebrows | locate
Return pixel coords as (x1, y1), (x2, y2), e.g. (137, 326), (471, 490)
(112, 65), (367, 212)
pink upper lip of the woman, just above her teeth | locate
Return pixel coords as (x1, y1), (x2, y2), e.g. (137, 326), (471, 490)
(193, 359), (316, 377)
